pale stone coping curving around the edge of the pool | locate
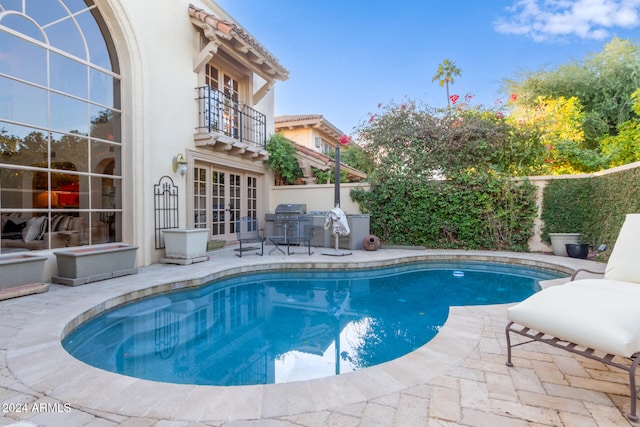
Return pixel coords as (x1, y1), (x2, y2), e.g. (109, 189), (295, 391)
(6, 250), (604, 422)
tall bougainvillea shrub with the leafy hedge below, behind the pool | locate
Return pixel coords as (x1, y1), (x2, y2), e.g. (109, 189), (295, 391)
(351, 102), (537, 251)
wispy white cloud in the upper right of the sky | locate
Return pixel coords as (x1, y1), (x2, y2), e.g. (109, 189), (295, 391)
(494, 0), (640, 41)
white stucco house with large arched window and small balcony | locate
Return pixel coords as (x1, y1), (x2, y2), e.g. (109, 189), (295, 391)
(0, 0), (288, 278)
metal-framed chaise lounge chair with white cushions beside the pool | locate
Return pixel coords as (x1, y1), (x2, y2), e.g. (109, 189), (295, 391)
(506, 214), (640, 421)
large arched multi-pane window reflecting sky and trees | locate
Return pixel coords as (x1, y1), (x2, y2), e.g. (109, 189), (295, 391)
(0, 0), (122, 253)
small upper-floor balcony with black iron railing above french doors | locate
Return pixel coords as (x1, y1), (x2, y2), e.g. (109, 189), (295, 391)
(194, 86), (269, 160)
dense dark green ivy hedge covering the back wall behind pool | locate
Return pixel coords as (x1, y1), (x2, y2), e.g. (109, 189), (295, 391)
(351, 175), (536, 251)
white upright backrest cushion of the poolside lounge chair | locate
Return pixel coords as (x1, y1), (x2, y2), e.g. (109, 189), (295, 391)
(604, 214), (640, 283)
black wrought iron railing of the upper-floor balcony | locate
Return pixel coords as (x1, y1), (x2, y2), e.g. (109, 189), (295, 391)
(196, 86), (267, 149)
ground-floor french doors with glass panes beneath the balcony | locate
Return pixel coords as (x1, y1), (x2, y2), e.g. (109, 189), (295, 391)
(193, 165), (258, 240)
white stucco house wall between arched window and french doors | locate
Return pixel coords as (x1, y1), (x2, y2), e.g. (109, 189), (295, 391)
(96, 0), (274, 265)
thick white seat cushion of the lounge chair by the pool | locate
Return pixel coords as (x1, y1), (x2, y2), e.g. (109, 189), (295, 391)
(507, 279), (640, 357)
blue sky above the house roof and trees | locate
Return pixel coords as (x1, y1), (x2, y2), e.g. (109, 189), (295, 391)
(216, 0), (640, 134)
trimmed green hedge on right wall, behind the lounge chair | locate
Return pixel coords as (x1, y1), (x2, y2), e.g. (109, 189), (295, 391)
(542, 169), (640, 254)
